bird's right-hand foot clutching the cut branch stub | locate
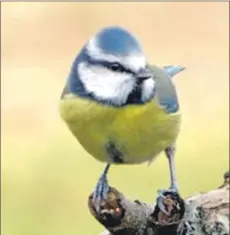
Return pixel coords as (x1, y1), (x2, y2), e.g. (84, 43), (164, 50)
(157, 186), (179, 215)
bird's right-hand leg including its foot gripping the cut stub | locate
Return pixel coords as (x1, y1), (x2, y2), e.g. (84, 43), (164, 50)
(157, 146), (178, 214)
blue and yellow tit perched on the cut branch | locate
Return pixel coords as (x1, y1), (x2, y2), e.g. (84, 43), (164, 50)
(59, 26), (185, 211)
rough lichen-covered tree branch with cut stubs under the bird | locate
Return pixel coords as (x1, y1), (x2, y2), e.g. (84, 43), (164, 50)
(88, 172), (230, 235)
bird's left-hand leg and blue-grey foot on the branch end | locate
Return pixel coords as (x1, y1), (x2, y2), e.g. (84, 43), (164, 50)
(92, 163), (110, 212)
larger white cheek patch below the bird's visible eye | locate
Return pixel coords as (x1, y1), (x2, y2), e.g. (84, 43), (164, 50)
(78, 63), (135, 105)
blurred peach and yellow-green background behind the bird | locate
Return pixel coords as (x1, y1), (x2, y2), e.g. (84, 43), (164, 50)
(1, 2), (229, 235)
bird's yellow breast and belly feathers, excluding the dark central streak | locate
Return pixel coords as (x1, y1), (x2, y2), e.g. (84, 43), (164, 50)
(60, 95), (180, 164)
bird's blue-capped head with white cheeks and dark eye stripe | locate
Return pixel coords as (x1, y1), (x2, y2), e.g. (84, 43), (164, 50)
(70, 27), (155, 106)
